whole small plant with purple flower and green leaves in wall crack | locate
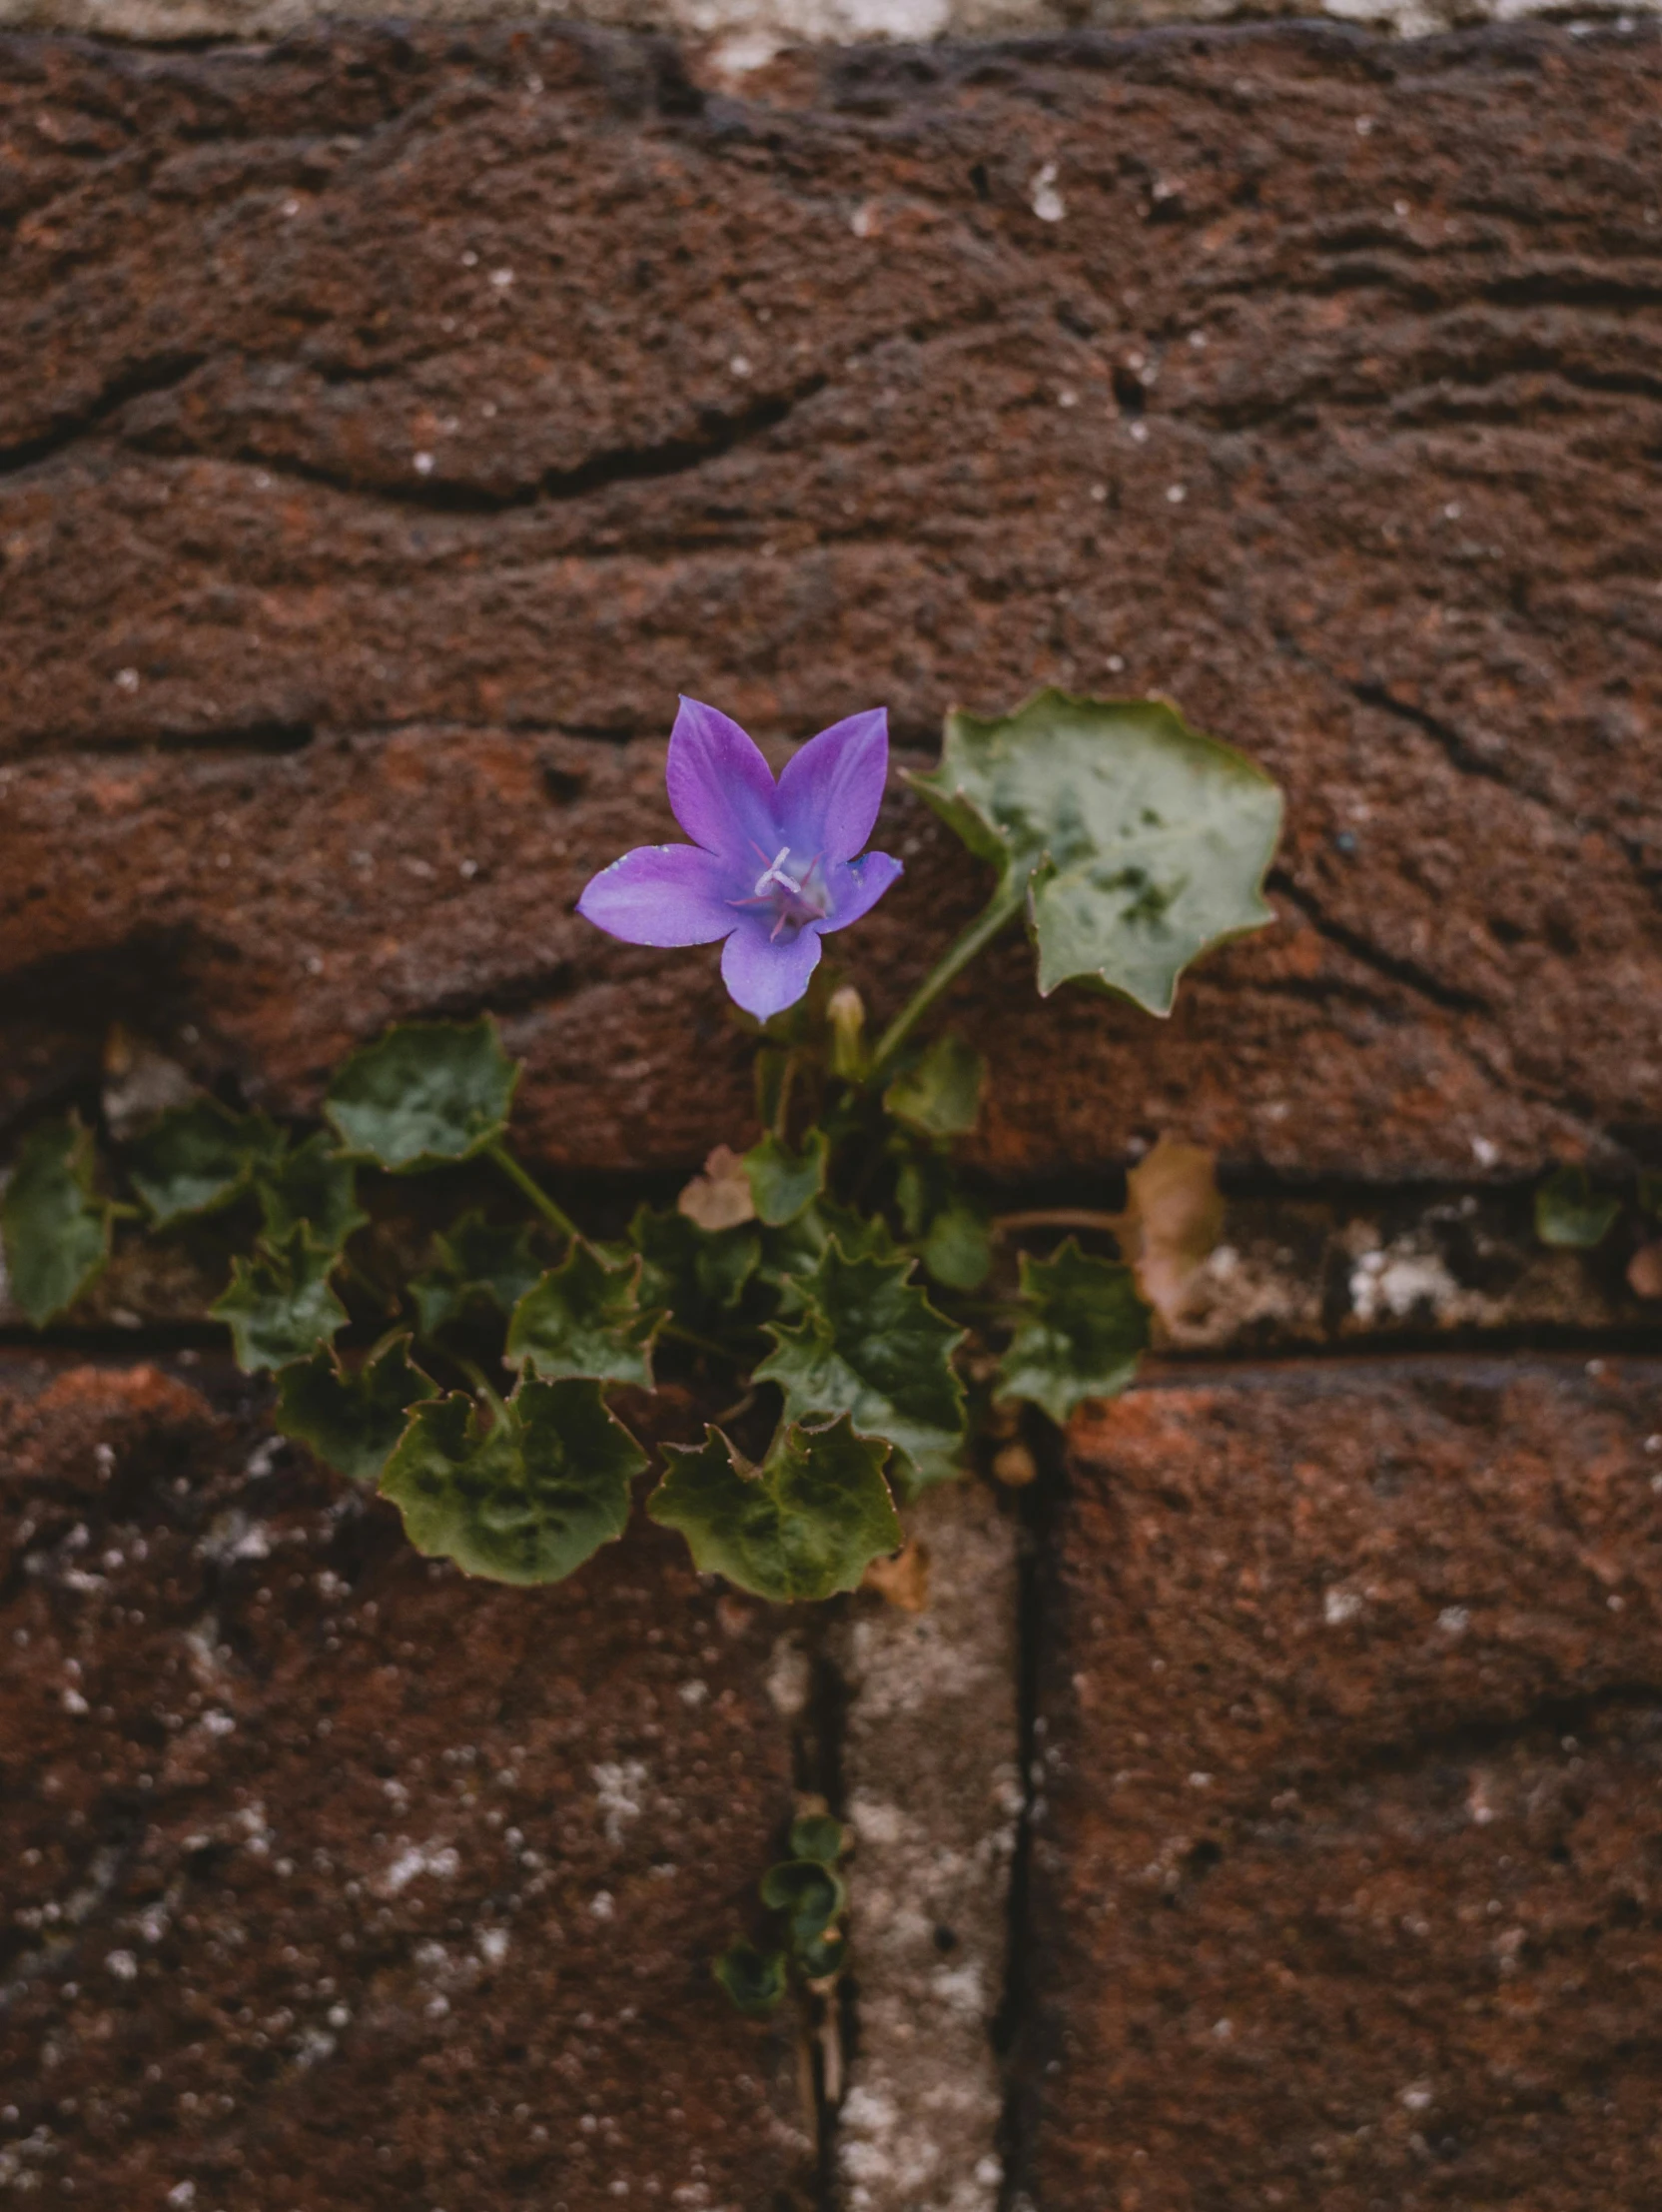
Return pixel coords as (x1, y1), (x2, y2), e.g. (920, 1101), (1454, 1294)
(0, 690), (1279, 1601)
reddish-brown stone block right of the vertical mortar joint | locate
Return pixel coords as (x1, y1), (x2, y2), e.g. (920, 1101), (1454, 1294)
(1030, 1358), (1662, 2212)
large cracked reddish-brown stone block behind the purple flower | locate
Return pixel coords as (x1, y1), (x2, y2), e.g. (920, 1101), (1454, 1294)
(0, 29), (1662, 1177)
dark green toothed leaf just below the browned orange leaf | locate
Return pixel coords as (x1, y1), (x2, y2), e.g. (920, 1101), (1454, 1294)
(999, 1237), (1150, 1427)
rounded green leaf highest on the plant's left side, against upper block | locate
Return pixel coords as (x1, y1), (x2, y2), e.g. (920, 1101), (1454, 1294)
(323, 1015), (519, 1175)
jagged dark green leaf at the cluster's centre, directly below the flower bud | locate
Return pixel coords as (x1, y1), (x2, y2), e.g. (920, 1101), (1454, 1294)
(756, 1239), (964, 1495)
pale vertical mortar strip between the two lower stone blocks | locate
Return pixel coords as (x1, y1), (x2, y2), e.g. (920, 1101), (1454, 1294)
(835, 1485), (1021, 2212)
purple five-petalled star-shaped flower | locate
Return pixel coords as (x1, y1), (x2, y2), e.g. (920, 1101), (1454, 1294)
(577, 699), (902, 1022)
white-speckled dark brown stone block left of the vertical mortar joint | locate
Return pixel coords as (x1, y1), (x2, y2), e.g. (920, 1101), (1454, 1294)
(0, 1361), (809, 2212)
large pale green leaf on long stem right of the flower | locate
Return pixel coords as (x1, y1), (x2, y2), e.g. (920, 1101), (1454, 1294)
(908, 690), (1281, 1013)
